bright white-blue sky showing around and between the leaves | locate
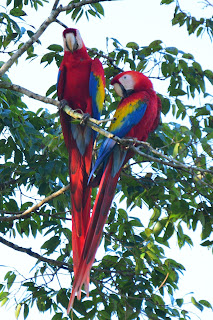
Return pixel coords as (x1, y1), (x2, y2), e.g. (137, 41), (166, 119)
(0, 0), (213, 320)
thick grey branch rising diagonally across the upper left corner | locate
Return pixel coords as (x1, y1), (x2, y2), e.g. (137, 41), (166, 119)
(0, 0), (111, 77)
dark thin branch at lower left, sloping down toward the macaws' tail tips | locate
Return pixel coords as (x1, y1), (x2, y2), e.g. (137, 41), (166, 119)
(0, 237), (72, 271)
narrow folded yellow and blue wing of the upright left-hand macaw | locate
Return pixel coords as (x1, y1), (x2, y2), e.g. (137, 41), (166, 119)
(89, 59), (105, 120)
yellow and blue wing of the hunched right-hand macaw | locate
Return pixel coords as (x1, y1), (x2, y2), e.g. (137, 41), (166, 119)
(109, 93), (148, 138)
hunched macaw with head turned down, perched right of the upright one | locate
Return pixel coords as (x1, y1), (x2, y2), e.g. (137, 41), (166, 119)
(68, 71), (161, 313)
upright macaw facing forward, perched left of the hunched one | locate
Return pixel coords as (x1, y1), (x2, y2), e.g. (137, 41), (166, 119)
(57, 28), (105, 297)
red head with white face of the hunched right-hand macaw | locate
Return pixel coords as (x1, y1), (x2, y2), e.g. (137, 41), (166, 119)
(111, 71), (153, 98)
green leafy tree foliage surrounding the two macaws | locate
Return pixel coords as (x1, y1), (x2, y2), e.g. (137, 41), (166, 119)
(0, 0), (213, 320)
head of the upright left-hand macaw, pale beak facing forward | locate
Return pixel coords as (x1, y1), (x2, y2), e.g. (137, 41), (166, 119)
(63, 28), (84, 53)
